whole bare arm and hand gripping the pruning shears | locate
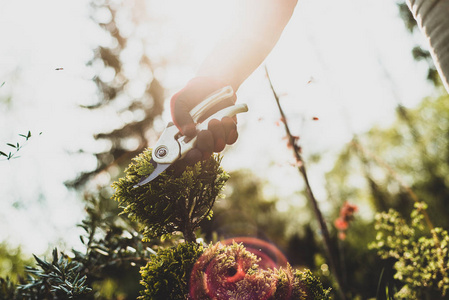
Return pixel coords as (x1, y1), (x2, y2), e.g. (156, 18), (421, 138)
(171, 0), (297, 164)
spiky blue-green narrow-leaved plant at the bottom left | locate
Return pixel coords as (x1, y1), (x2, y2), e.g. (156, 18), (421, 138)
(18, 249), (91, 299)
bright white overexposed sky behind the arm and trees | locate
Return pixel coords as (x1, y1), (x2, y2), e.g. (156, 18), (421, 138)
(0, 0), (431, 253)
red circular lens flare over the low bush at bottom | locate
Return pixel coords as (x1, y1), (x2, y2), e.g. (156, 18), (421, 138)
(189, 237), (290, 300)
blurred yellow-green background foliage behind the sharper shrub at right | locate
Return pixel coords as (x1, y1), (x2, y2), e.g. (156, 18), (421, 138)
(326, 96), (449, 299)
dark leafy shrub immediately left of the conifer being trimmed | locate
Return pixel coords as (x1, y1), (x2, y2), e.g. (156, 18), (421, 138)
(73, 190), (153, 300)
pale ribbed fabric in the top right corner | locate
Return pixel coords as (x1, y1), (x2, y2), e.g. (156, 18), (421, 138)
(407, 0), (449, 93)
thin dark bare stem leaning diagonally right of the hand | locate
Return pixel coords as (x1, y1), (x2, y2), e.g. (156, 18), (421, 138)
(265, 66), (346, 300)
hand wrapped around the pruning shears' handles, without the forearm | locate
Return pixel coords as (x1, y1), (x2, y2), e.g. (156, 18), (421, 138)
(171, 77), (238, 165)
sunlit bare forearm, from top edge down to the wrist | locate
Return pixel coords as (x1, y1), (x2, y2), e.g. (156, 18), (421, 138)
(197, 0), (297, 91)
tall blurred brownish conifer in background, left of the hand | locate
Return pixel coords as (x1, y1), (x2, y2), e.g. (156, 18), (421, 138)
(67, 0), (164, 188)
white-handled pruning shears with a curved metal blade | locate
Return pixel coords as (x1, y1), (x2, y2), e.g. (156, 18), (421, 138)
(134, 86), (248, 187)
